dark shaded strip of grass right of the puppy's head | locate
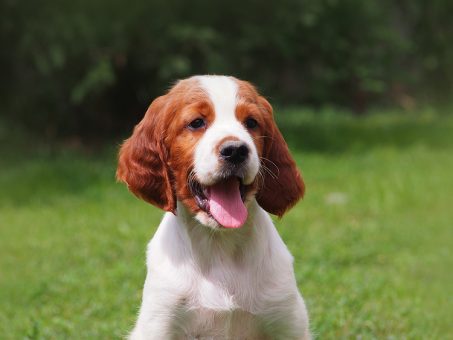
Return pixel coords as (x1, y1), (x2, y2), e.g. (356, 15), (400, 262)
(276, 110), (453, 153)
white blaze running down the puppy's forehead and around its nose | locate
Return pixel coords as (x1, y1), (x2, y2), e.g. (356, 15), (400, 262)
(194, 76), (259, 185)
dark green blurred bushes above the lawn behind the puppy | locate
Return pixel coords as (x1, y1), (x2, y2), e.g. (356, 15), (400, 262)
(0, 0), (453, 137)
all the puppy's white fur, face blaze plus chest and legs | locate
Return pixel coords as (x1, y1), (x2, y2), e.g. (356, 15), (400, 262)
(130, 76), (310, 340)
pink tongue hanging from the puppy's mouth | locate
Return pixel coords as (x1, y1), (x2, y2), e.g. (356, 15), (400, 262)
(209, 178), (247, 228)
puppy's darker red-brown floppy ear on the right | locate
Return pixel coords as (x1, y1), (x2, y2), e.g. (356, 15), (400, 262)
(257, 97), (305, 217)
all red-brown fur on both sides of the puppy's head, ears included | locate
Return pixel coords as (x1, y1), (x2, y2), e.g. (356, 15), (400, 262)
(117, 78), (304, 216)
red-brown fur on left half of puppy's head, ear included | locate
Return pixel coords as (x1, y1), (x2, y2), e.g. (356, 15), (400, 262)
(117, 79), (209, 212)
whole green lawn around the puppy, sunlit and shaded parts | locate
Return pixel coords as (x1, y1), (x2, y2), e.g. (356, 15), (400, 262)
(0, 109), (453, 339)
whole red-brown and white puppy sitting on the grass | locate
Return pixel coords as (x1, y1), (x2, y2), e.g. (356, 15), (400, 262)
(117, 76), (310, 339)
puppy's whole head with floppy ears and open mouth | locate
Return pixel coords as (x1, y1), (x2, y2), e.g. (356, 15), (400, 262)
(117, 76), (304, 228)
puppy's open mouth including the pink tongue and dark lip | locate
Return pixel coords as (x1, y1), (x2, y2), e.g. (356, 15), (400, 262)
(190, 177), (248, 228)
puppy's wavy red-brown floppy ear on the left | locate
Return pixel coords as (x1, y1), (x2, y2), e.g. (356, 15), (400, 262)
(116, 96), (176, 212)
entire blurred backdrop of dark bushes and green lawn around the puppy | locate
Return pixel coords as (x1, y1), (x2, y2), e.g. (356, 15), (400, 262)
(0, 0), (453, 339)
